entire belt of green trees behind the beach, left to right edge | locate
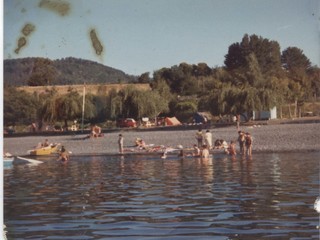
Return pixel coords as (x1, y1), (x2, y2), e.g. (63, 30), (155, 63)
(4, 35), (320, 128)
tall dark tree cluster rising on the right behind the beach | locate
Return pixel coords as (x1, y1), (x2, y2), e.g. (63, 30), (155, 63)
(147, 35), (320, 116)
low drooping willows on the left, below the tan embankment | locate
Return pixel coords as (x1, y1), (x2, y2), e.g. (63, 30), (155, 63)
(4, 85), (169, 127)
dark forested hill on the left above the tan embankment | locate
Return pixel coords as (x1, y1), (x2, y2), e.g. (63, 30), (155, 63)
(4, 57), (136, 86)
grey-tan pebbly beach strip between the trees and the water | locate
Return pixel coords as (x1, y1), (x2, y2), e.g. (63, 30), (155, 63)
(3, 123), (320, 156)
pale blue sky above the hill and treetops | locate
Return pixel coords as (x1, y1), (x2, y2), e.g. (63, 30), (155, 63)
(3, 0), (320, 75)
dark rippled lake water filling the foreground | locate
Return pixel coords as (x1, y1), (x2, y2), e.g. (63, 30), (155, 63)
(4, 152), (320, 240)
